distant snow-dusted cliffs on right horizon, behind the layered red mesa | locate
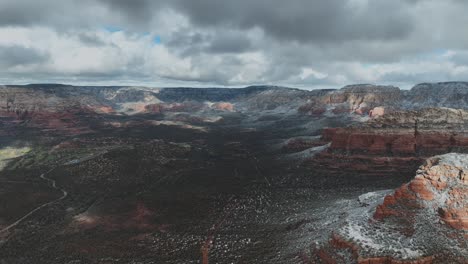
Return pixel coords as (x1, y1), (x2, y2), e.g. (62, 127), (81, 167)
(299, 82), (468, 116)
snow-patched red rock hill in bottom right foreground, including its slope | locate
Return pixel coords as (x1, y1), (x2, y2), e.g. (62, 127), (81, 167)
(315, 153), (468, 264)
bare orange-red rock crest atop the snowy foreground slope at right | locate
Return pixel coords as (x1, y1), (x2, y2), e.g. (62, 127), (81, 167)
(374, 154), (468, 230)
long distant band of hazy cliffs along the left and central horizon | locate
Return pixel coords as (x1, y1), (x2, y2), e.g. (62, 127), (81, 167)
(0, 84), (317, 135)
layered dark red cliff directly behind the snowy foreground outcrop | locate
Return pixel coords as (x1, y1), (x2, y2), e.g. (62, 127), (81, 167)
(311, 108), (468, 175)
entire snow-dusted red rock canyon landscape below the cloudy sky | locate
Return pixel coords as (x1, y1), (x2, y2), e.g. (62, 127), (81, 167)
(0, 82), (468, 264)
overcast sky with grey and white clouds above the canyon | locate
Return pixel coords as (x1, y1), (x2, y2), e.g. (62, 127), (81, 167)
(0, 0), (468, 89)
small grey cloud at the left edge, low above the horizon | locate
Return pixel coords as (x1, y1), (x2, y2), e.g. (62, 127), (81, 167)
(0, 45), (49, 68)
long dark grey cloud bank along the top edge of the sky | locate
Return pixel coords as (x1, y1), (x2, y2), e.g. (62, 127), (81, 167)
(0, 0), (463, 43)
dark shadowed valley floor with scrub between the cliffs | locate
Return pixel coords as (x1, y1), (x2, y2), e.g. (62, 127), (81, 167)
(0, 117), (410, 264)
